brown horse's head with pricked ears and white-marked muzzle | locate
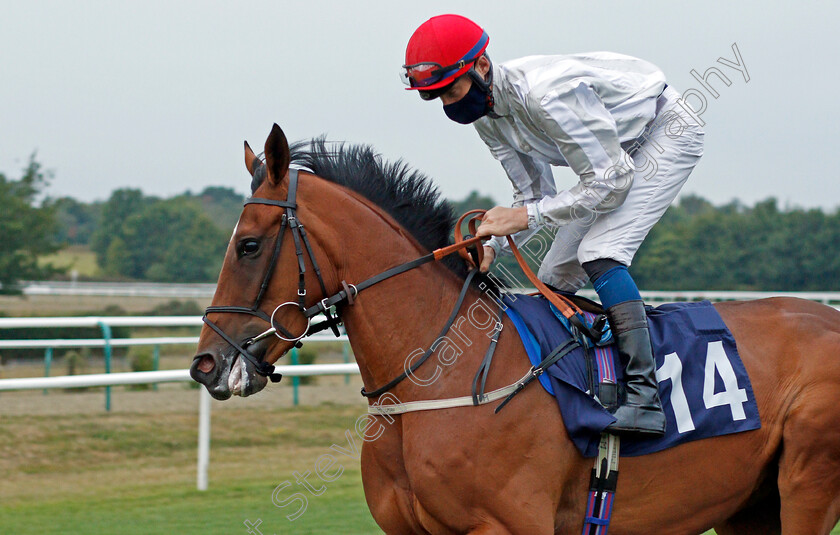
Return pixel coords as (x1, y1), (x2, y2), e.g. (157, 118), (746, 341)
(190, 124), (334, 399)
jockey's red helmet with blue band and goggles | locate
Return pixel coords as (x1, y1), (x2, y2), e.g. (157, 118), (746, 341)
(401, 15), (490, 91)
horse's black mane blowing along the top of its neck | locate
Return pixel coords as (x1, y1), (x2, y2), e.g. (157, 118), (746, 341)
(290, 136), (466, 276)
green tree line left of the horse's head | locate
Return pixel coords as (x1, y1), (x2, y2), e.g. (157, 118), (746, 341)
(0, 156), (236, 293)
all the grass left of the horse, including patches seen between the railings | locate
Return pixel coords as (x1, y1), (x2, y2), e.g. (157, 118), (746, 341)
(0, 296), (840, 535)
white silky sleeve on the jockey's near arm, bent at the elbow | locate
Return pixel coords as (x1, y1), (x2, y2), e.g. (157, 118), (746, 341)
(528, 80), (633, 225)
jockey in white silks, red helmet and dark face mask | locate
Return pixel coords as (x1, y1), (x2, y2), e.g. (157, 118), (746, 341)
(402, 15), (703, 436)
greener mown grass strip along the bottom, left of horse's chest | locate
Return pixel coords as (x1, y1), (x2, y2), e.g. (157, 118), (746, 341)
(0, 469), (381, 535)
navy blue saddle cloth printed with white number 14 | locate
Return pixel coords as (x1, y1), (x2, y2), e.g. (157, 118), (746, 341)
(503, 295), (761, 457)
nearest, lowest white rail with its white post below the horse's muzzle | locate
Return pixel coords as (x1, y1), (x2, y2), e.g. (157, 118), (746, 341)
(0, 362), (359, 490)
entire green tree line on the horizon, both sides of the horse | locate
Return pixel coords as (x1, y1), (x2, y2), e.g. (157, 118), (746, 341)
(0, 157), (840, 292)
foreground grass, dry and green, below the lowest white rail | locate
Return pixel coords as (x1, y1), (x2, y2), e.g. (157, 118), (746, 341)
(0, 396), (378, 535)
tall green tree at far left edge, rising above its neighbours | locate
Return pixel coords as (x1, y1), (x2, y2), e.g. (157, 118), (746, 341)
(0, 154), (58, 293)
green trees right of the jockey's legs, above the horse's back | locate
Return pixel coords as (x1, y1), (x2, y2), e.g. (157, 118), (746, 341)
(631, 197), (840, 291)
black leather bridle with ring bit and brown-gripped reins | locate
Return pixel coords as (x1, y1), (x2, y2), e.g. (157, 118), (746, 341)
(202, 168), (592, 397)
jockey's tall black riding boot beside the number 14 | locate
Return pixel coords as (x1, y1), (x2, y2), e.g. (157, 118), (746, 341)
(607, 301), (665, 437)
